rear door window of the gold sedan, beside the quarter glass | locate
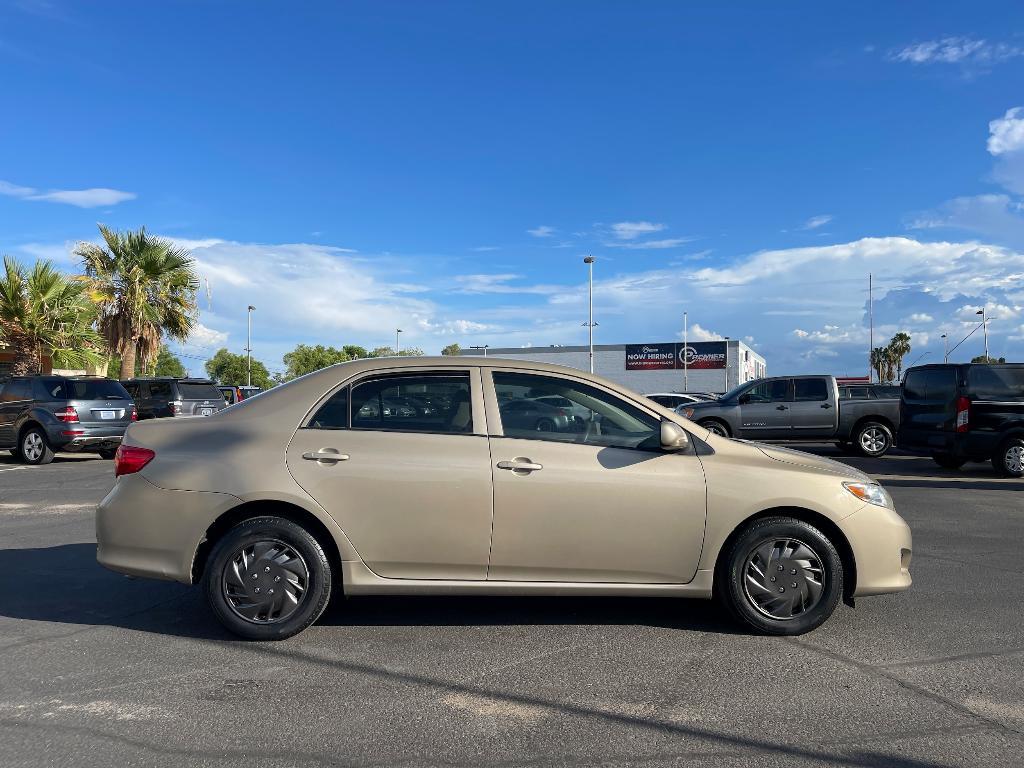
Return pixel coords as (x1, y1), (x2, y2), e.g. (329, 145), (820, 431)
(350, 373), (473, 433)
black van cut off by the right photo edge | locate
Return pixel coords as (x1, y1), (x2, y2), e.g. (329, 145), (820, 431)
(897, 362), (1024, 477)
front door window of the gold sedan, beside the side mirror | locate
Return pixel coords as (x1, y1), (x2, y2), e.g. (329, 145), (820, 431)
(493, 372), (660, 451)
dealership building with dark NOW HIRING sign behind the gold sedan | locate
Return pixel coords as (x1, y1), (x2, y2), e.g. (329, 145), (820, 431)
(462, 339), (768, 393)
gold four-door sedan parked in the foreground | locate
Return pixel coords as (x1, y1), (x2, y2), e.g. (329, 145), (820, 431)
(96, 357), (911, 639)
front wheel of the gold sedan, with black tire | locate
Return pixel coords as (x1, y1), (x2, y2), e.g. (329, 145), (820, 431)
(715, 517), (844, 635)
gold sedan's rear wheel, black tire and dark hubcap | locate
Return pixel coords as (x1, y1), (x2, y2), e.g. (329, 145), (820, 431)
(205, 517), (332, 640)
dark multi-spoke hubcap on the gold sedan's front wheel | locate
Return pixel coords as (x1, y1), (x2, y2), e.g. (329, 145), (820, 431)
(743, 539), (824, 621)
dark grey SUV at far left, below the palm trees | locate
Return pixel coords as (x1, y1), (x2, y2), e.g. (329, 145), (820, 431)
(0, 376), (137, 464)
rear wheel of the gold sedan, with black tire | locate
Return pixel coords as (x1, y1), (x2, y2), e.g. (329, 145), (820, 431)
(204, 516), (332, 640)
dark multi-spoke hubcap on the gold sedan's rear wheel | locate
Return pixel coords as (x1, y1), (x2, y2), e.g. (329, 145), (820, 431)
(221, 539), (309, 624)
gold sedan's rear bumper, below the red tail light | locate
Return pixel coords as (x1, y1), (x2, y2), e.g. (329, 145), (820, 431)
(96, 474), (242, 584)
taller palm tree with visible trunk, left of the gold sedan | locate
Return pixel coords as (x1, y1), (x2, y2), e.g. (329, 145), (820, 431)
(75, 224), (199, 379)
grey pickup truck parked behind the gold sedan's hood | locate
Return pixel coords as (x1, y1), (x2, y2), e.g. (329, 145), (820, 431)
(677, 376), (900, 457)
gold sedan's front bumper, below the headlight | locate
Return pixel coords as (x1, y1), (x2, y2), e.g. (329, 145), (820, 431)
(840, 504), (913, 597)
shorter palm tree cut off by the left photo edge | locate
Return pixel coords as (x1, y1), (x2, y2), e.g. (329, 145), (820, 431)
(0, 256), (103, 376)
